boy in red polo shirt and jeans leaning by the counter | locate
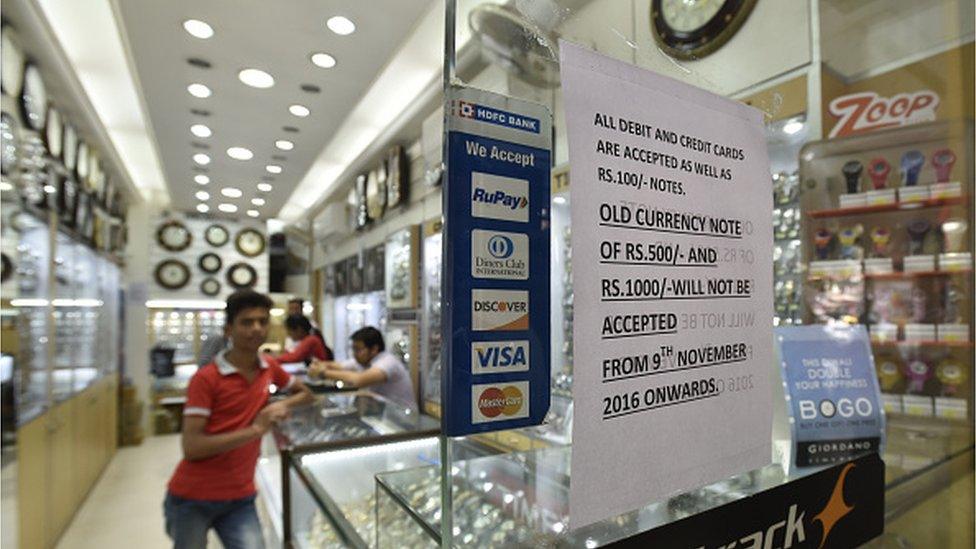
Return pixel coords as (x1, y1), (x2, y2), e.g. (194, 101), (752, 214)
(164, 290), (312, 549)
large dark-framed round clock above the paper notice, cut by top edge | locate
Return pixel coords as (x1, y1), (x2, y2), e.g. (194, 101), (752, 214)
(651, 0), (756, 60)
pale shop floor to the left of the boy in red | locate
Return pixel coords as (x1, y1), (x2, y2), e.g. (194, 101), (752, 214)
(58, 435), (180, 549)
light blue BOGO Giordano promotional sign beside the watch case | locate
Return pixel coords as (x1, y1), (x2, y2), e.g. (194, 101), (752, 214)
(776, 325), (885, 467)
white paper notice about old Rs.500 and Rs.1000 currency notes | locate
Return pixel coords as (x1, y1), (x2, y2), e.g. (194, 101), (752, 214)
(560, 42), (775, 528)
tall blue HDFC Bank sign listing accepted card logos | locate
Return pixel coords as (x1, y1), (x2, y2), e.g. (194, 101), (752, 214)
(441, 87), (552, 436)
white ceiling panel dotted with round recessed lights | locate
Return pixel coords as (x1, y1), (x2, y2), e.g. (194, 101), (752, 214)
(118, 0), (432, 218)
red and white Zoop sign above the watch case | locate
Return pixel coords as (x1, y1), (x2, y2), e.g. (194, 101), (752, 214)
(829, 90), (939, 138)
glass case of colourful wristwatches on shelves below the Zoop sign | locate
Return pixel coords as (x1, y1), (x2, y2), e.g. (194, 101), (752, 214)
(800, 120), (974, 422)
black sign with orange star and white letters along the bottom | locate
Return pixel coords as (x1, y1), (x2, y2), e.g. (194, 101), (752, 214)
(615, 454), (884, 549)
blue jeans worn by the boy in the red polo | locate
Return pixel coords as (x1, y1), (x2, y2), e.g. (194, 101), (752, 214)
(163, 492), (264, 549)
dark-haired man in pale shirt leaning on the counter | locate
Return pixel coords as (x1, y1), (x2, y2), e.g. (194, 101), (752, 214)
(308, 326), (417, 409)
